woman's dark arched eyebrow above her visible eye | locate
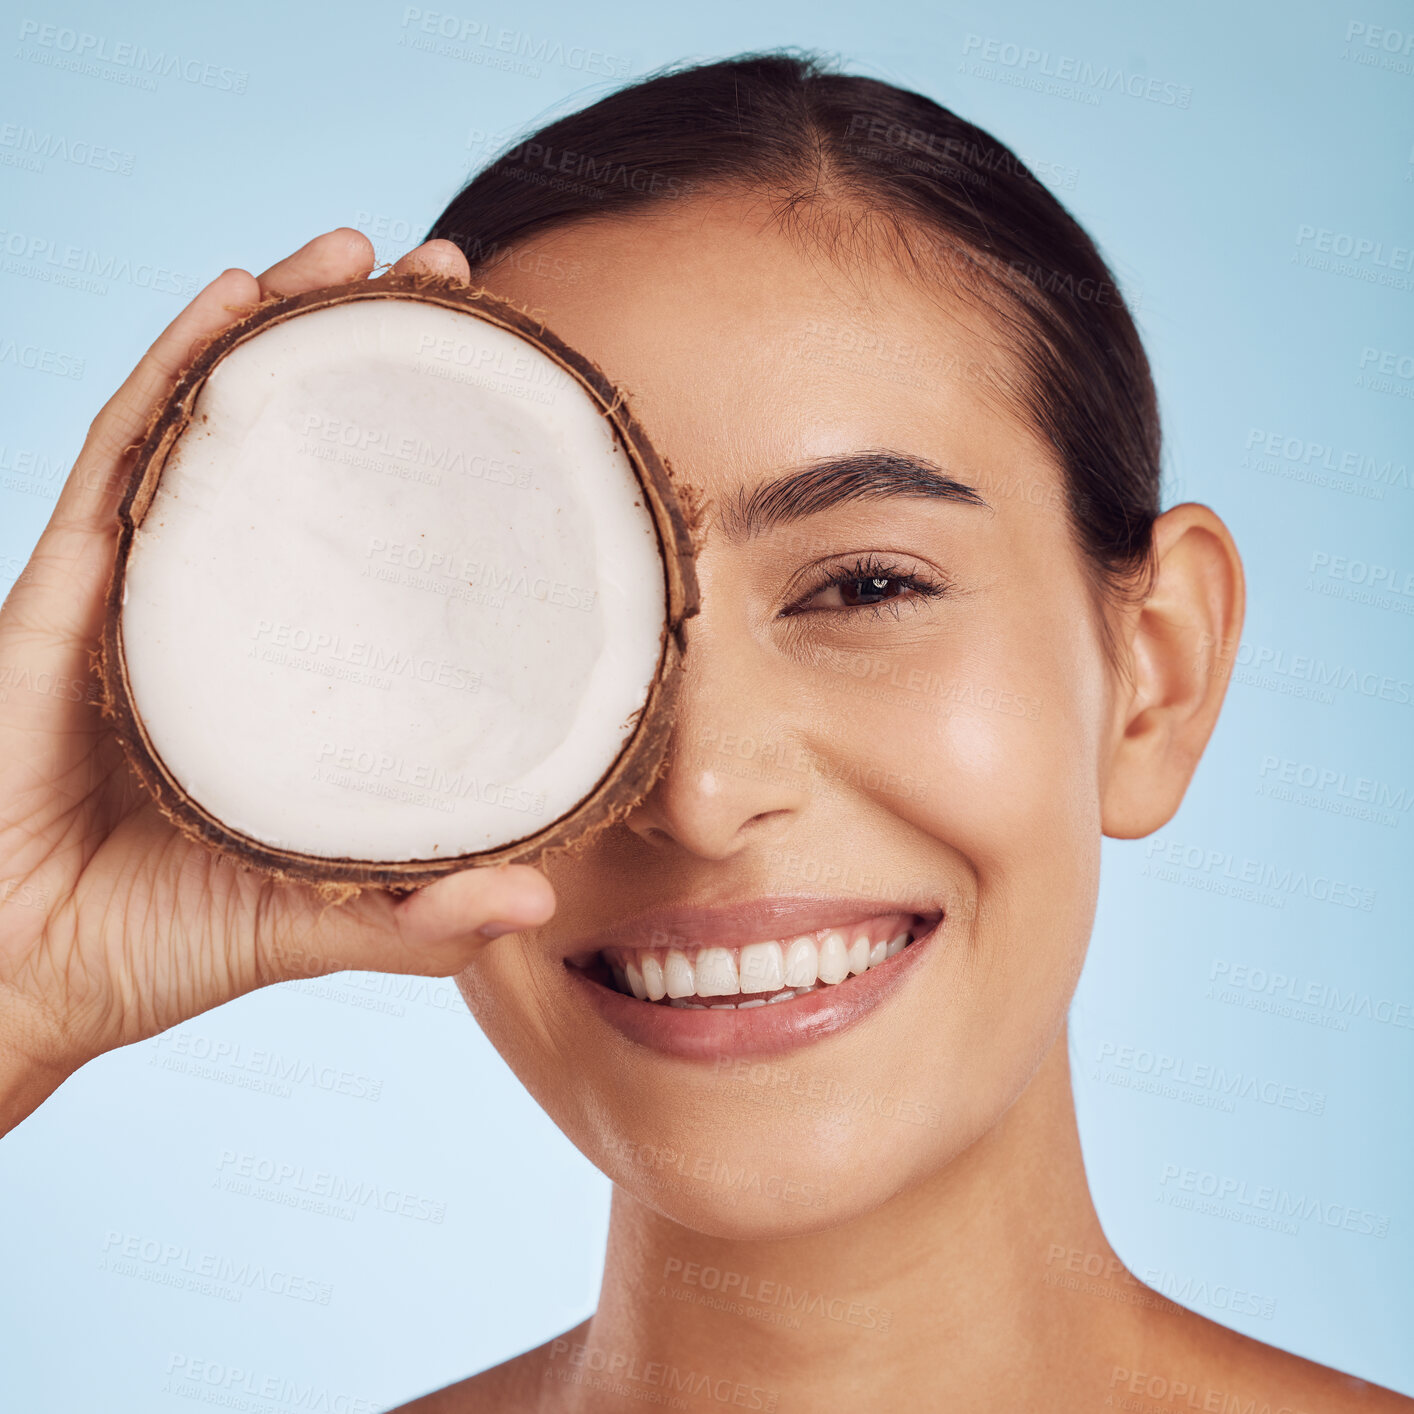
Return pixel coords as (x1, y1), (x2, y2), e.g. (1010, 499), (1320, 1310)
(720, 451), (991, 540)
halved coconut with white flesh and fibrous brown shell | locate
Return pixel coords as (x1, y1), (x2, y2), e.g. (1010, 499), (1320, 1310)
(100, 276), (697, 888)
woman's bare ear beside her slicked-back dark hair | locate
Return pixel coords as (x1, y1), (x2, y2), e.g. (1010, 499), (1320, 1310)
(1100, 502), (1247, 840)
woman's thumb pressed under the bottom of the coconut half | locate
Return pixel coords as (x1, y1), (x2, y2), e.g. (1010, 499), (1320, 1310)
(257, 864), (556, 981)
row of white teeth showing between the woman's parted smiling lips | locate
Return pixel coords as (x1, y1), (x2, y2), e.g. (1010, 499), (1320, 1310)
(567, 913), (936, 1011)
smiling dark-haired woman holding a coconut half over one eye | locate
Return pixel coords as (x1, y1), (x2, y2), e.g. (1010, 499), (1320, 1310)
(0, 55), (1414, 1411)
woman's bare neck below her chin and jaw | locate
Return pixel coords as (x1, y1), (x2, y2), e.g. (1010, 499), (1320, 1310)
(568, 1027), (1176, 1414)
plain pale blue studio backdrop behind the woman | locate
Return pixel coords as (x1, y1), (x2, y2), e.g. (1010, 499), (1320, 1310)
(0, 0), (1414, 1414)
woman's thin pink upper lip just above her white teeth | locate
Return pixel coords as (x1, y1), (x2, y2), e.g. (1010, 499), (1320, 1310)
(563, 894), (945, 964)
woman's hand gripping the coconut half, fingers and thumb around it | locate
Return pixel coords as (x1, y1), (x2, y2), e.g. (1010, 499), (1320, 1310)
(0, 228), (554, 1133)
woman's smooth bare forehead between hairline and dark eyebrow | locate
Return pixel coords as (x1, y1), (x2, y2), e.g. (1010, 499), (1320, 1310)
(477, 198), (1059, 502)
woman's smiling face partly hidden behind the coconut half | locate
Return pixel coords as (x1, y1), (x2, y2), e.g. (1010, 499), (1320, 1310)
(458, 199), (1117, 1236)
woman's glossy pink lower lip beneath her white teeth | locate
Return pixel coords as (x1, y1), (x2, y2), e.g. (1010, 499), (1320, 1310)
(566, 921), (943, 1061)
